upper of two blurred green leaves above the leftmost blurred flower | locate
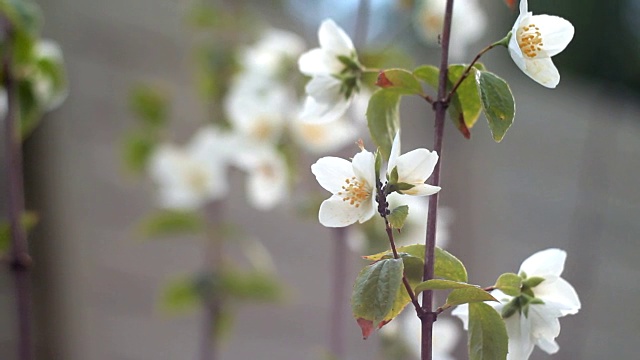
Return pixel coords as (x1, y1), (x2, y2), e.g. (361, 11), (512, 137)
(129, 84), (169, 128)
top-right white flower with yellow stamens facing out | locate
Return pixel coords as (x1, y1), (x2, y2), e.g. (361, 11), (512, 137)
(509, 0), (574, 88)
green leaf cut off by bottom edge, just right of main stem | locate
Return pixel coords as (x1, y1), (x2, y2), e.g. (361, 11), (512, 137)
(469, 302), (509, 360)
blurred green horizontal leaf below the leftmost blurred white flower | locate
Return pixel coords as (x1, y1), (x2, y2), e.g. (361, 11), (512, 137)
(138, 210), (205, 238)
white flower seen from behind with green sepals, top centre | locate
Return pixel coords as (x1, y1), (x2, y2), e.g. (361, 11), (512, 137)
(298, 19), (359, 121)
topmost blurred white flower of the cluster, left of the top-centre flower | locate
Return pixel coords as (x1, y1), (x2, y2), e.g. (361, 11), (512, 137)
(239, 28), (306, 77)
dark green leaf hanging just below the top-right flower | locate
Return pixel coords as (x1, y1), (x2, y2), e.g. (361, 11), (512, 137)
(476, 71), (516, 142)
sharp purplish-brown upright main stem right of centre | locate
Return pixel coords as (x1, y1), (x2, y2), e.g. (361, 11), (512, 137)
(420, 0), (453, 360)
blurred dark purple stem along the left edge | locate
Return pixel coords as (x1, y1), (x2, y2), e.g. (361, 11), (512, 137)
(1, 18), (33, 360)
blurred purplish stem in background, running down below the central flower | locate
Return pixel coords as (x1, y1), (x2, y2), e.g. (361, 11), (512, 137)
(329, 228), (347, 359)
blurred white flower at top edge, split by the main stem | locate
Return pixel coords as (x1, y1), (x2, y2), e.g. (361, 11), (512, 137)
(413, 0), (487, 61)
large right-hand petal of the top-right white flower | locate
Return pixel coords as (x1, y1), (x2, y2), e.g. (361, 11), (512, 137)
(530, 15), (575, 57)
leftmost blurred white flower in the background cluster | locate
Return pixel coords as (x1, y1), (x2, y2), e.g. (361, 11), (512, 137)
(149, 127), (229, 210)
